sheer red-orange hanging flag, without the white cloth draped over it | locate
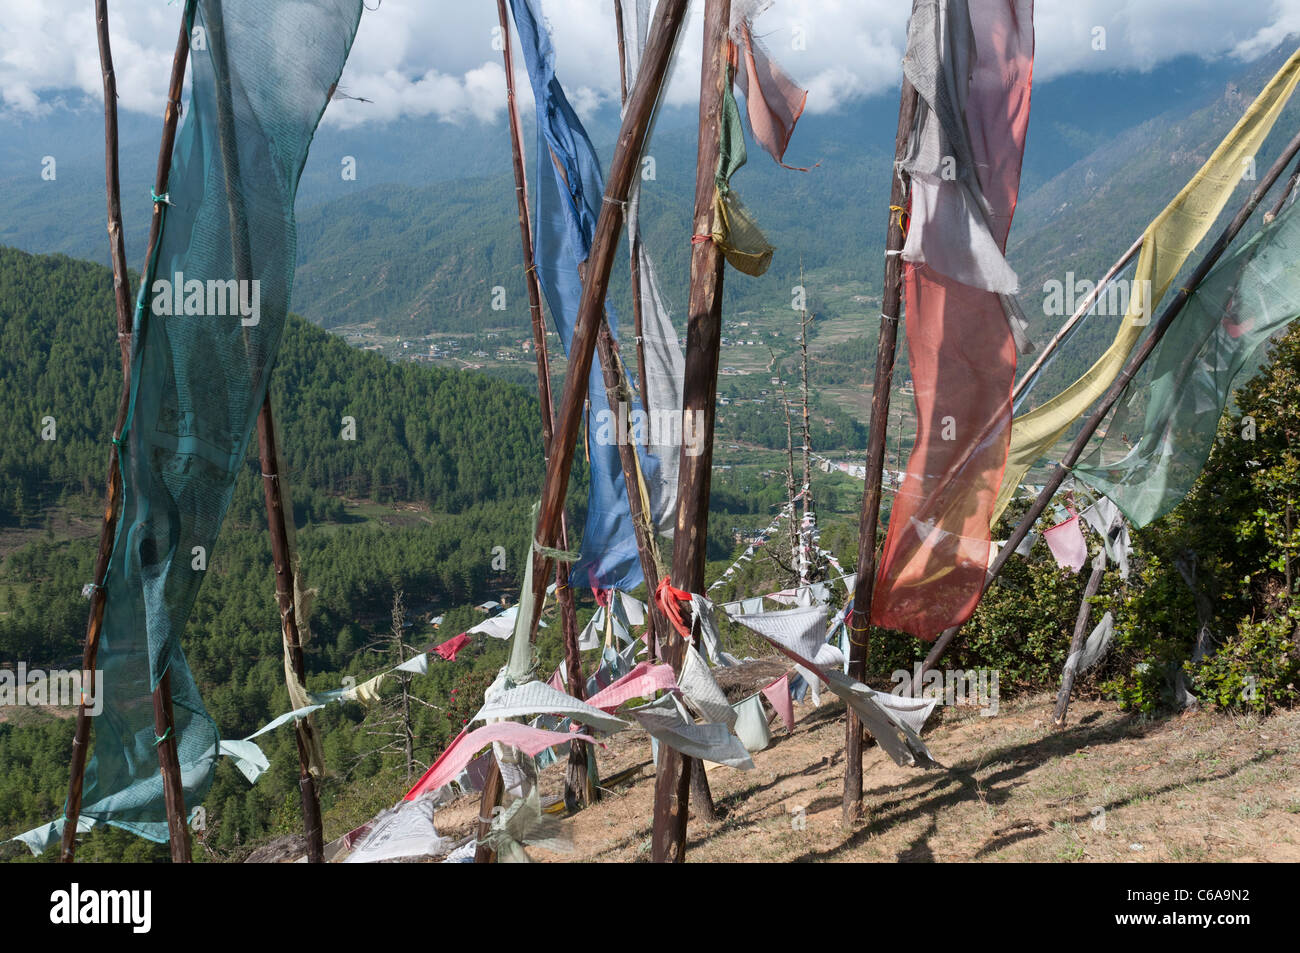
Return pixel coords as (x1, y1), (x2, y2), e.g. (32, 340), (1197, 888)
(871, 0), (1034, 641)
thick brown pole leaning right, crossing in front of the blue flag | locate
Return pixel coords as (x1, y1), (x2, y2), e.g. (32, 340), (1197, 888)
(529, 0), (688, 636)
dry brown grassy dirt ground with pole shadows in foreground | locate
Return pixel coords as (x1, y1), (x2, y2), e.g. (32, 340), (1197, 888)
(436, 696), (1300, 863)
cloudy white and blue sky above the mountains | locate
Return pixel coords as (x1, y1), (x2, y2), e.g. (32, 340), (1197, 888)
(0, 0), (1300, 126)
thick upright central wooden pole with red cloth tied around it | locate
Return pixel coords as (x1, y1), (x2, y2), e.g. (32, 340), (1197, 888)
(651, 0), (731, 863)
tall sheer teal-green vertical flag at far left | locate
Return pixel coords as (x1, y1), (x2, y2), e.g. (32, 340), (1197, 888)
(69, 0), (361, 841)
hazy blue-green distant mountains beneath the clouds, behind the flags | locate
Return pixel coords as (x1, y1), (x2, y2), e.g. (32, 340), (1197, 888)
(0, 44), (1300, 379)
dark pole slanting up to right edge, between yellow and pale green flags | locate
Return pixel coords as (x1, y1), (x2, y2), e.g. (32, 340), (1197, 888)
(905, 128), (1300, 692)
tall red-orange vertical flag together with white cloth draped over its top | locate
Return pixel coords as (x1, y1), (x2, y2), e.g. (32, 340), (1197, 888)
(871, 0), (1034, 640)
